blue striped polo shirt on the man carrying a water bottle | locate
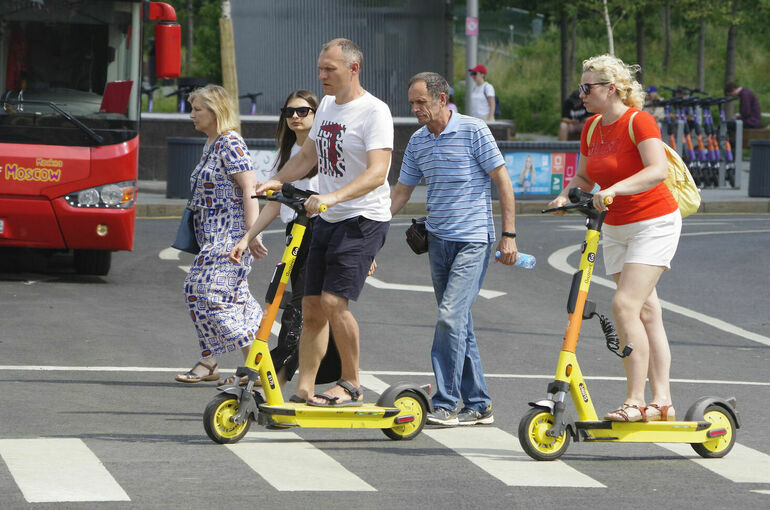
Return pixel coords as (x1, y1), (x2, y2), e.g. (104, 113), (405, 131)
(398, 113), (505, 243)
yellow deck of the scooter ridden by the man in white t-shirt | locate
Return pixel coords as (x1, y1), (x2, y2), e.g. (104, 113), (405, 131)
(259, 402), (406, 429)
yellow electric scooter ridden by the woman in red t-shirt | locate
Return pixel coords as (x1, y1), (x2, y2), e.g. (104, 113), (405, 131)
(519, 188), (740, 460)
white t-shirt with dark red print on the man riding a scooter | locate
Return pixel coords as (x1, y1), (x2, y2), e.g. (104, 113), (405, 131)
(308, 92), (393, 223)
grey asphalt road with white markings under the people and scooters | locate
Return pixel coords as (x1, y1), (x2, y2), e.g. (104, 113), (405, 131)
(0, 211), (770, 509)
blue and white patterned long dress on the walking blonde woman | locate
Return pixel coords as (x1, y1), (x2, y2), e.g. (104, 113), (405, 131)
(184, 131), (262, 358)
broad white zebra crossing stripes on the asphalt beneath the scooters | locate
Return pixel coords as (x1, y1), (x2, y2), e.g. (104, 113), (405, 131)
(0, 426), (770, 503)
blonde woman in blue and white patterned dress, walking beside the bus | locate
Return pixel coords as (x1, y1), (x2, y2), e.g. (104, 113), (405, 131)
(175, 85), (267, 383)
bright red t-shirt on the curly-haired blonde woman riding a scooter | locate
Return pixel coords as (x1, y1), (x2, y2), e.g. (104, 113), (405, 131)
(580, 108), (679, 225)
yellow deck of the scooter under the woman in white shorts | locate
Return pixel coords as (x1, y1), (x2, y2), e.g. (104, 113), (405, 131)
(574, 420), (712, 443)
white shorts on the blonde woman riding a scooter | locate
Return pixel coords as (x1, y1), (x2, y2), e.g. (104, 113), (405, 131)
(602, 209), (682, 275)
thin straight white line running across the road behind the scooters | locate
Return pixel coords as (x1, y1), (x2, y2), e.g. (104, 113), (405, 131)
(0, 366), (770, 386)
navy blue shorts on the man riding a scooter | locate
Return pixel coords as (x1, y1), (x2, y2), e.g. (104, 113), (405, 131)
(305, 216), (390, 301)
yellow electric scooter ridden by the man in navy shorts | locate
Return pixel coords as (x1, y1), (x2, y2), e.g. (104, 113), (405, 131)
(203, 183), (433, 444)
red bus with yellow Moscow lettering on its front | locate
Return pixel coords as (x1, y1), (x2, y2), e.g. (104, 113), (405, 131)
(0, 0), (181, 275)
